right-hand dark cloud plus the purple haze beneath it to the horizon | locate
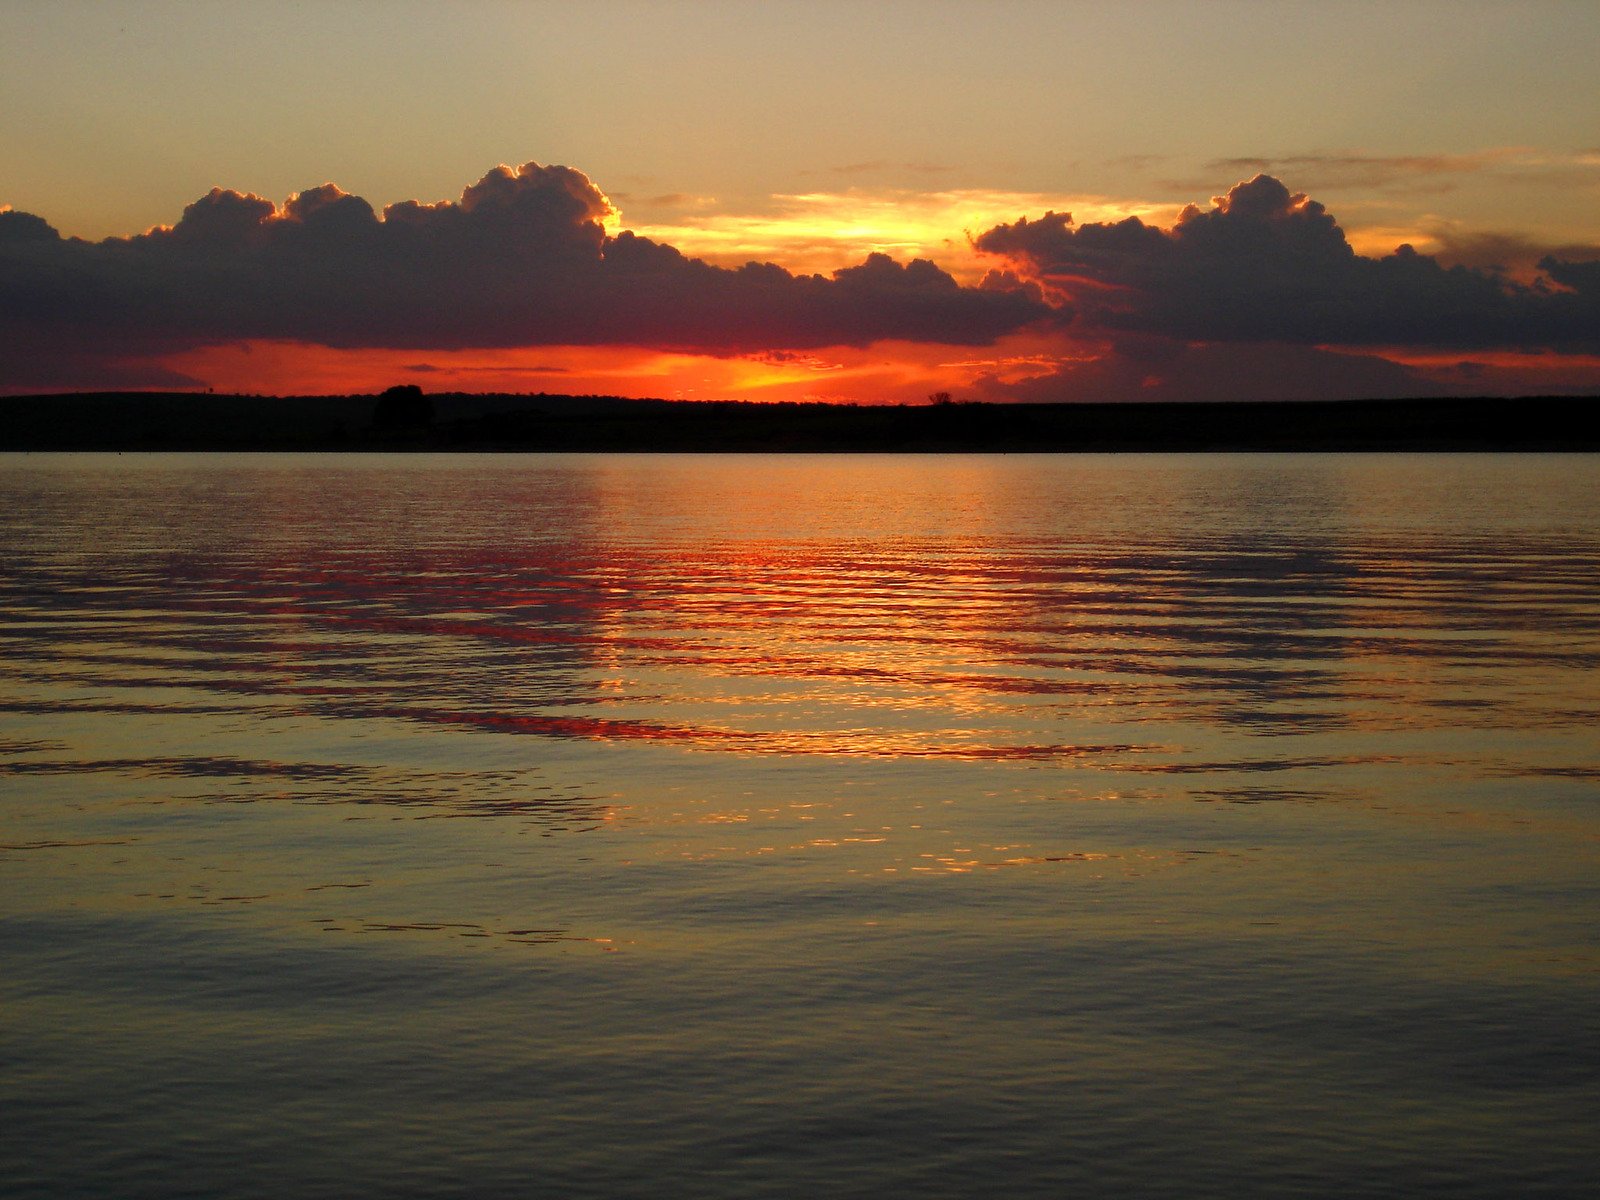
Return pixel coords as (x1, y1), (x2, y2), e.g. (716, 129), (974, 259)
(974, 174), (1600, 400)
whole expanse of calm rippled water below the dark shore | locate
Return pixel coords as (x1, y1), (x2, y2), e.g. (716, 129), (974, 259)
(0, 456), (1600, 1198)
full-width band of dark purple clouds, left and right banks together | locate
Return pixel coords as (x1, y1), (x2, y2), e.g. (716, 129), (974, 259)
(0, 163), (1600, 398)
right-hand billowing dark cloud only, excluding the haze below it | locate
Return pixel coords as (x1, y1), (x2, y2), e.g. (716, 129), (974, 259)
(974, 174), (1600, 352)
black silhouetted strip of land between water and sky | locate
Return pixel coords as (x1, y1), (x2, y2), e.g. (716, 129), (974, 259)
(0, 387), (1600, 453)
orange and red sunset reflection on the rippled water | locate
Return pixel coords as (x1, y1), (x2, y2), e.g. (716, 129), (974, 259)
(34, 458), (1594, 780)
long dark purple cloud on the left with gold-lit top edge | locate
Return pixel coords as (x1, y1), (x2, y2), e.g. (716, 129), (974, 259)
(0, 163), (1046, 386)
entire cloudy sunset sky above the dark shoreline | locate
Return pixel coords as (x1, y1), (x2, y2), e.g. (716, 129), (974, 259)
(0, 0), (1600, 403)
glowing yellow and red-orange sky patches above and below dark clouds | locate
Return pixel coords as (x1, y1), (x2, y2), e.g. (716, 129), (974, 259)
(112, 176), (1600, 403)
